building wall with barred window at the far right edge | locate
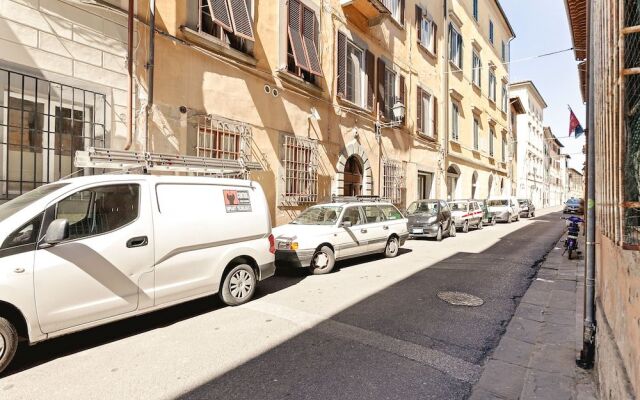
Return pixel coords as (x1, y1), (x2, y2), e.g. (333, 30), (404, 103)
(566, 0), (640, 399)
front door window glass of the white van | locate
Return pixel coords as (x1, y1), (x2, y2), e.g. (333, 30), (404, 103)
(56, 184), (140, 239)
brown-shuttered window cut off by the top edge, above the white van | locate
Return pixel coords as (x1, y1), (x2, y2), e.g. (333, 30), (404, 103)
(198, 0), (255, 54)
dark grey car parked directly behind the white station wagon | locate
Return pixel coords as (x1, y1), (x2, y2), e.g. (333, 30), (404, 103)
(407, 200), (456, 241)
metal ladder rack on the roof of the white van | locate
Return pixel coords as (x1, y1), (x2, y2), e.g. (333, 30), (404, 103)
(74, 147), (262, 175)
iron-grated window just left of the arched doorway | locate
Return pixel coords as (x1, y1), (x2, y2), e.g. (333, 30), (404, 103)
(282, 135), (318, 203)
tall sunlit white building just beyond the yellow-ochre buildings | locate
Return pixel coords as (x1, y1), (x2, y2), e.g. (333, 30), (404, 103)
(510, 81), (547, 208)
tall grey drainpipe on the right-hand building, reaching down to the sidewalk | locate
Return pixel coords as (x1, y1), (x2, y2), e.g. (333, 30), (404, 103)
(577, 1), (596, 369)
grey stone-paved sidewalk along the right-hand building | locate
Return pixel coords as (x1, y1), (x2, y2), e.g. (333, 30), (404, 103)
(470, 230), (596, 400)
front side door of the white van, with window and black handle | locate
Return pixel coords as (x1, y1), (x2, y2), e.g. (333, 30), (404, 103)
(34, 180), (154, 333)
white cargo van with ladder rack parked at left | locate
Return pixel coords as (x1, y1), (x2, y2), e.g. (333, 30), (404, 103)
(0, 175), (275, 372)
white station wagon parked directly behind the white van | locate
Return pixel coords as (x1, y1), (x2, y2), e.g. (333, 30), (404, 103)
(273, 200), (409, 275)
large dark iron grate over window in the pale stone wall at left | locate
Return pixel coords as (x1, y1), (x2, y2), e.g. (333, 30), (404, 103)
(0, 68), (108, 200)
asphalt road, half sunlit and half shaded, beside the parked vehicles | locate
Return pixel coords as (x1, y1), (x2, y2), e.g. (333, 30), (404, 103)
(0, 208), (563, 400)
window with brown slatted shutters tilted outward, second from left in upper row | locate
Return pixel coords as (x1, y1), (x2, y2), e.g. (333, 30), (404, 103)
(287, 0), (322, 84)
